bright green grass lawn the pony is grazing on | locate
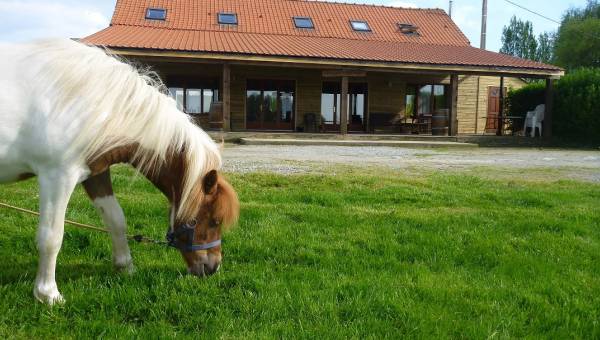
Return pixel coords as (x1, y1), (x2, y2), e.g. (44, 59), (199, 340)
(0, 168), (600, 339)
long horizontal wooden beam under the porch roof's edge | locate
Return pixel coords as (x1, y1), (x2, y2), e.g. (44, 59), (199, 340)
(109, 48), (565, 79)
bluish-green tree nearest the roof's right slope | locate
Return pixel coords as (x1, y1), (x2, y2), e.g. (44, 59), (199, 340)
(500, 16), (538, 60)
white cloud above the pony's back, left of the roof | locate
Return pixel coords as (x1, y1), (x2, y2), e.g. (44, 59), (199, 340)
(0, 0), (110, 42)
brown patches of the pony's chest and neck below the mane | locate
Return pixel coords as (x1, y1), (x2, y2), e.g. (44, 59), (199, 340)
(89, 145), (184, 203)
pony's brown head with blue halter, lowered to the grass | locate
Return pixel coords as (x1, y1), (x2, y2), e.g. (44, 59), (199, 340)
(169, 170), (239, 277)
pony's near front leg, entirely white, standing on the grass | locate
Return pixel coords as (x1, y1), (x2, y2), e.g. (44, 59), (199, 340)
(33, 170), (80, 305)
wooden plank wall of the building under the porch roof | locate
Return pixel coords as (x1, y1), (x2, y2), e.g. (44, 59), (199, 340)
(140, 58), (525, 134)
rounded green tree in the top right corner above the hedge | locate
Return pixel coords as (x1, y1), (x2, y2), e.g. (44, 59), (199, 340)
(555, 0), (600, 70)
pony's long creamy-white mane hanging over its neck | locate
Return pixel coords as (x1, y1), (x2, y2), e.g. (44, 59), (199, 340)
(23, 40), (221, 220)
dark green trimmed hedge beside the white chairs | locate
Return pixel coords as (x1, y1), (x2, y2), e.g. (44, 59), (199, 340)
(507, 68), (600, 143)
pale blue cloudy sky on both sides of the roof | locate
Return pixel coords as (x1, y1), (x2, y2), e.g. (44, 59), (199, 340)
(0, 0), (586, 51)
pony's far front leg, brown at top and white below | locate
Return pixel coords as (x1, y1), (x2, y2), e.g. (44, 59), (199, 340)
(83, 170), (134, 273)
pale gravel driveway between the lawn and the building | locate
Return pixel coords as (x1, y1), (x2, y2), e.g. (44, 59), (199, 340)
(224, 145), (600, 182)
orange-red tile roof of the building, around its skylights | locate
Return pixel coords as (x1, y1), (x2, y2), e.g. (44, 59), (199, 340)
(84, 0), (560, 71)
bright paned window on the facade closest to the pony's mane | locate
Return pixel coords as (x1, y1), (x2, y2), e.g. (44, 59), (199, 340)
(169, 87), (219, 115)
